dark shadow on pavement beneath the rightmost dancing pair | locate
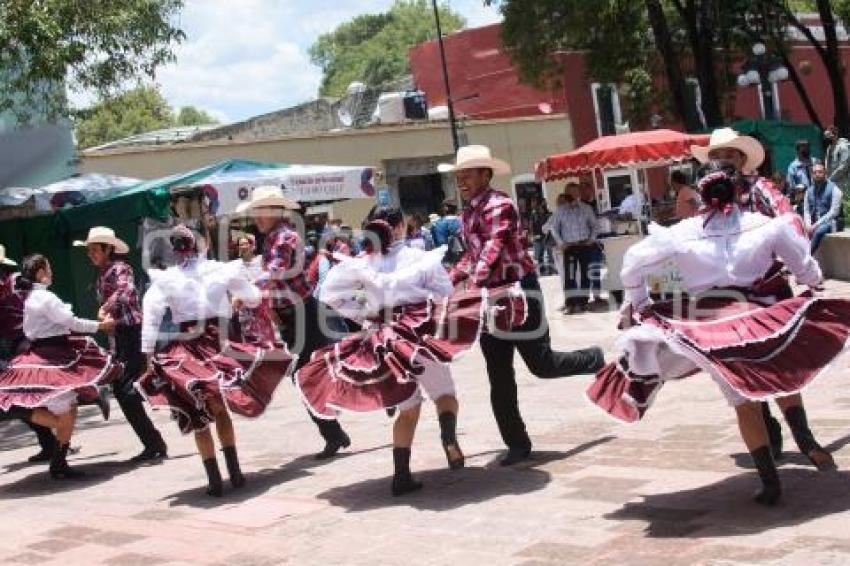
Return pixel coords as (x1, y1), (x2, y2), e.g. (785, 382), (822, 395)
(605, 469), (850, 538)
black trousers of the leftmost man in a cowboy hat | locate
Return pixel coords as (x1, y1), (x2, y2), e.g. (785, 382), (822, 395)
(112, 325), (165, 450)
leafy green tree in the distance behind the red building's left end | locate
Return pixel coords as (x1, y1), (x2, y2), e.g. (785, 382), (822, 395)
(310, 0), (466, 97)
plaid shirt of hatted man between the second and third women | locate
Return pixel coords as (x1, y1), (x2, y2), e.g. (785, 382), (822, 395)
(256, 224), (313, 308)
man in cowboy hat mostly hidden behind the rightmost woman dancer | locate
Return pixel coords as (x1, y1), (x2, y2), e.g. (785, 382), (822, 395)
(691, 128), (814, 460)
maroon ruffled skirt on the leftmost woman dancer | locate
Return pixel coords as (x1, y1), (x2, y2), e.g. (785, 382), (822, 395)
(0, 336), (123, 411)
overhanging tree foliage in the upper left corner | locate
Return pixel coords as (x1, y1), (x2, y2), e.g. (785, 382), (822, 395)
(0, 0), (185, 122)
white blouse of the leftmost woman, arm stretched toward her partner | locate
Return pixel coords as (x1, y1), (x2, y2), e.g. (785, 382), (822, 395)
(23, 283), (98, 340)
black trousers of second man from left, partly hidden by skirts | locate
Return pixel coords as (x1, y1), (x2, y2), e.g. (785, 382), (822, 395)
(277, 296), (345, 442)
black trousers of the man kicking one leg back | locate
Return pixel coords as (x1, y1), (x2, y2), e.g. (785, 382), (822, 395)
(481, 273), (588, 449)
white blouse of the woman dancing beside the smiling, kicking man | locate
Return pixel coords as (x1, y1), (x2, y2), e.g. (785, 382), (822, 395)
(319, 242), (454, 321)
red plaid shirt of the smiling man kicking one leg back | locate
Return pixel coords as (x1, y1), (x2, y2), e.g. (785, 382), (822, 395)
(452, 188), (534, 287)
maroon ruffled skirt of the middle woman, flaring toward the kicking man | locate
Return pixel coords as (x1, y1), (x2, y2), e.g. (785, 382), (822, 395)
(296, 285), (526, 419)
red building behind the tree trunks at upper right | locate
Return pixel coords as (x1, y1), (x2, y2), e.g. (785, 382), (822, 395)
(410, 22), (850, 146)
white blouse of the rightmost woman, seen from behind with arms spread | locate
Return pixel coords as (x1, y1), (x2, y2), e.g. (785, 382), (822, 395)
(620, 207), (823, 307)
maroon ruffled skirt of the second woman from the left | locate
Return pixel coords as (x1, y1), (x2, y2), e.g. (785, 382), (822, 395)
(136, 321), (292, 434)
